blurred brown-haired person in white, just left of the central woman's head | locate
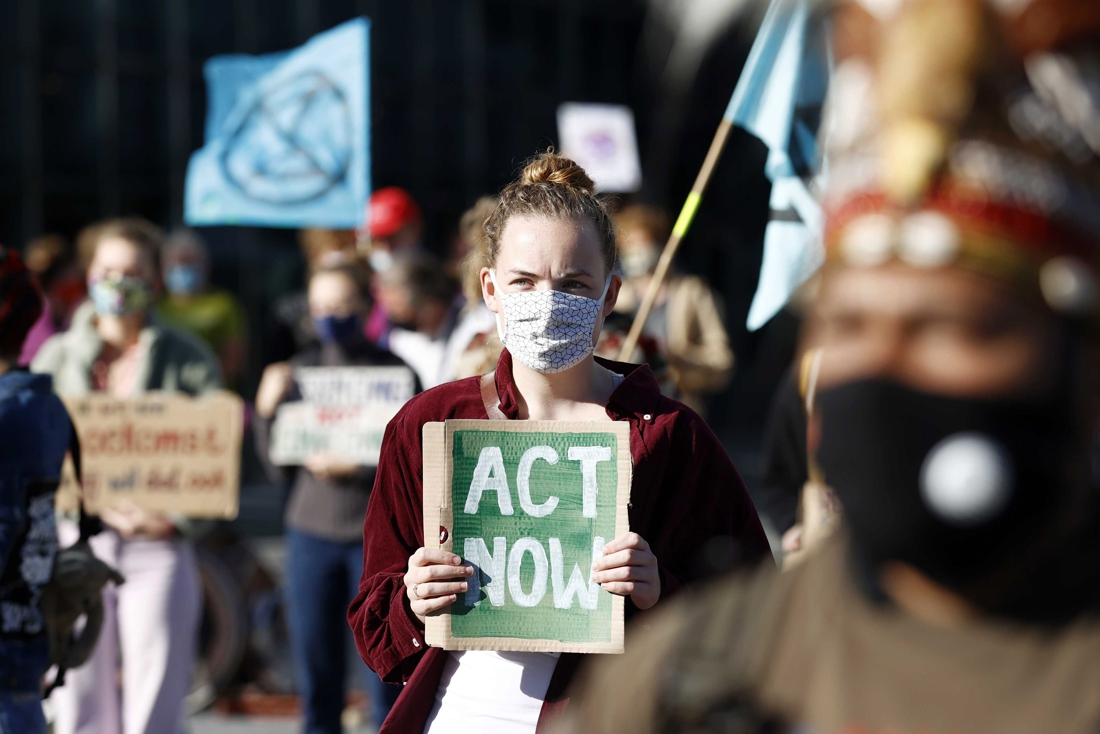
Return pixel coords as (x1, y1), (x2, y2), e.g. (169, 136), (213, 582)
(441, 196), (503, 382)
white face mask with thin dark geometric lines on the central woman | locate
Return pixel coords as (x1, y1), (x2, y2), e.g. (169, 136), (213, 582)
(490, 271), (612, 373)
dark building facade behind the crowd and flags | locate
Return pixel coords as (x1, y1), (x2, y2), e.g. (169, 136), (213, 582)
(0, 0), (790, 459)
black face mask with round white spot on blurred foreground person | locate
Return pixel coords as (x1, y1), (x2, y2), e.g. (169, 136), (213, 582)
(815, 380), (1091, 611)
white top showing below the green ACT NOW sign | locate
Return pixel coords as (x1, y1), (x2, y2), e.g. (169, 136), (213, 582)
(424, 650), (560, 734)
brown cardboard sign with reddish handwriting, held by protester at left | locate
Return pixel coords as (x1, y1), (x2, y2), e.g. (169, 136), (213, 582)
(57, 392), (244, 519)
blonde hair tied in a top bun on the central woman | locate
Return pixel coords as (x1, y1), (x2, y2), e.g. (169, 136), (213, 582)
(485, 149), (617, 273)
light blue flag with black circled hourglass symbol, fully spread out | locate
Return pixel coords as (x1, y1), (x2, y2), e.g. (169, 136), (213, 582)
(184, 18), (371, 229)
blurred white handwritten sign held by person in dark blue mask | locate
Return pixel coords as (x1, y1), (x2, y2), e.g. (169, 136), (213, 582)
(271, 368), (415, 467)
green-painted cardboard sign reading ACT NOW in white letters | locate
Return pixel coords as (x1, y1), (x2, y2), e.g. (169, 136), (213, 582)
(424, 420), (633, 653)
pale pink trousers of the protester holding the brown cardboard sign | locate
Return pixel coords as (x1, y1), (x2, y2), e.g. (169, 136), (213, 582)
(52, 523), (202, 734)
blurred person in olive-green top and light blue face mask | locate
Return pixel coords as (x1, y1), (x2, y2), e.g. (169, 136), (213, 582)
(156, 229), (248, 387)
